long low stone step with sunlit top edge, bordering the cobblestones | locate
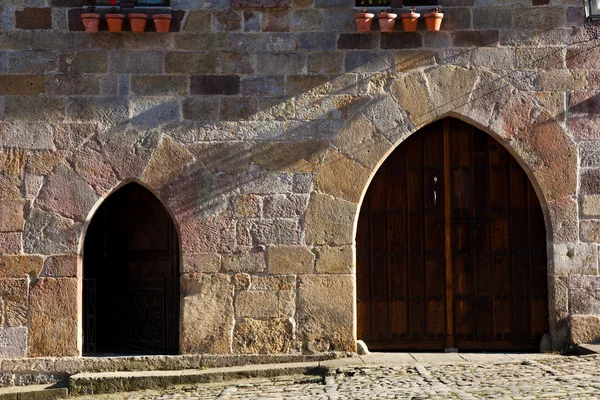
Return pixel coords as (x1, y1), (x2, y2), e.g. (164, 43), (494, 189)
(69, 362), (326, 396)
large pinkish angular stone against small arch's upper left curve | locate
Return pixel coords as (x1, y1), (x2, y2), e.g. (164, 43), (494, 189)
(38, 164), (99, 221)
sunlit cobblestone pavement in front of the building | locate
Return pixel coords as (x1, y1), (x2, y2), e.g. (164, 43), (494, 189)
(78, 356), (600, 400)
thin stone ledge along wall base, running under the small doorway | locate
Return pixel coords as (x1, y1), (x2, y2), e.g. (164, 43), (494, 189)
(0, 352), (355, 376)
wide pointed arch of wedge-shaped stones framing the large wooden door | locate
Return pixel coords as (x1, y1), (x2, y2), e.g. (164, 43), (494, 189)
(306, 66), (578, 348)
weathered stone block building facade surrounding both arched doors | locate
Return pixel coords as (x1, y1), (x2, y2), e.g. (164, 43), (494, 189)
(0, 0), (600, 357)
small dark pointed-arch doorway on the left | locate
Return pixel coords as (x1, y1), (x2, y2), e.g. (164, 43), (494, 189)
(83, 183), (179, 354)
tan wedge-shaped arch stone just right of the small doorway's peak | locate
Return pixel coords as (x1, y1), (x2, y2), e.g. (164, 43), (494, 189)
(142, 136), (194, 189)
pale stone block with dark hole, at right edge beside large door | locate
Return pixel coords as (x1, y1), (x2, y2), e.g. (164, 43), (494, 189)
(549, 243), (598, 275)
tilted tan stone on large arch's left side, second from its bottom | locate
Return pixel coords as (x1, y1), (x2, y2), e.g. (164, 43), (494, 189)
(315, 152), (370, 203)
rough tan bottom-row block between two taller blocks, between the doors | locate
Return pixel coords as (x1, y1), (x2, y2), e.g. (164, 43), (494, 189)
(233, 318), (294, 354)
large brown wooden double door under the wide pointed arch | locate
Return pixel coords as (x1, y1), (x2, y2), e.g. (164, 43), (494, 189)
(356, 118), (548, 351)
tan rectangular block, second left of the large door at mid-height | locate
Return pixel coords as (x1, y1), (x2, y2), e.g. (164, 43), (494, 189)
(267, 246), (315, 274)
